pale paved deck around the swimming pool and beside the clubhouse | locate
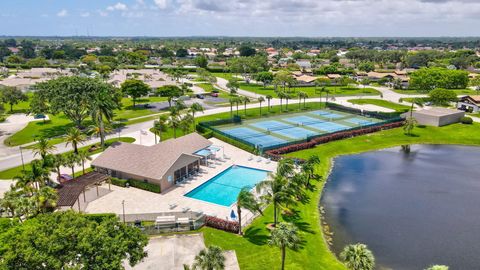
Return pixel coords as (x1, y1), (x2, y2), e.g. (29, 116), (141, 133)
(85, 138), (277, 223)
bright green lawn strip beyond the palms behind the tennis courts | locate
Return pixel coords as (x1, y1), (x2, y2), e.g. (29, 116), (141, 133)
(235, 83), (380, 98)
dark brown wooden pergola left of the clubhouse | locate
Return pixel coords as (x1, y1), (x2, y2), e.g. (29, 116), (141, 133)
(57, 172), (111, 212)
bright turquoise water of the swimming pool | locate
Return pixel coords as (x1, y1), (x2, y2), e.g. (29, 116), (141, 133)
(185, 166), (268, 206)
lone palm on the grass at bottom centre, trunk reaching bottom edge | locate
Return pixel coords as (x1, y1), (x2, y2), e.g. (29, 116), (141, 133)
(268, 222), (302, 270)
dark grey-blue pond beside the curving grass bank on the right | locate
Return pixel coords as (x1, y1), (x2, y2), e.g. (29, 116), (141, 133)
(321, 145), (480, 269)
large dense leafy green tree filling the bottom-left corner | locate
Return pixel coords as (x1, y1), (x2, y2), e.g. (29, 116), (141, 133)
(0, 211), (148, 269)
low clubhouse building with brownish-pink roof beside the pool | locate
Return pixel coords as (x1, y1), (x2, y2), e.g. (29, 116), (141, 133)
(92, 133), (218, 192)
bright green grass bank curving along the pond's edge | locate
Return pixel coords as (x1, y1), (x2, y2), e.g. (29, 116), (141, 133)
(202, 123), (480, 269)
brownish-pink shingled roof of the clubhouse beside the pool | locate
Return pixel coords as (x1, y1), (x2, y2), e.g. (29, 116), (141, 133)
(92, 133), (212, 179)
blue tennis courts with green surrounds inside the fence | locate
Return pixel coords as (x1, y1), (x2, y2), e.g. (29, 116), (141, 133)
(216, 109), (383, 149)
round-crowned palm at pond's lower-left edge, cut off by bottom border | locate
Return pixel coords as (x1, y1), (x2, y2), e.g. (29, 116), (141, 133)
(340, 244), (375, 270)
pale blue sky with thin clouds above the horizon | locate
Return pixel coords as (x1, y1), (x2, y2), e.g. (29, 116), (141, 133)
(0, 0), (480, 37)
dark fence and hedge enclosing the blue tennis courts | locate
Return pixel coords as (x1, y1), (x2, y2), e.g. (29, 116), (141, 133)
(197, 102), (403, 155)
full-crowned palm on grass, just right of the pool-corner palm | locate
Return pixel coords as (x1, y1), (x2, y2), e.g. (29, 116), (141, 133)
(256, 174), (294, 227)
